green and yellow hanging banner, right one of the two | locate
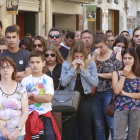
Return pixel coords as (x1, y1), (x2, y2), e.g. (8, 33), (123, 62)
(86, 5), (97, 21)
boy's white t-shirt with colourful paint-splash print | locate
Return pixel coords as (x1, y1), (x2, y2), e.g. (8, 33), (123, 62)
(21, 74), (54, 115)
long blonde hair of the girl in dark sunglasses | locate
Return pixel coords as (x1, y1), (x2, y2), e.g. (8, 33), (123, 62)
(43, 44), (64, 72)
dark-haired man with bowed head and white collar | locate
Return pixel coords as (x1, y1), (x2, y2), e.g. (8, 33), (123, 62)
(60, 31), (75, 49)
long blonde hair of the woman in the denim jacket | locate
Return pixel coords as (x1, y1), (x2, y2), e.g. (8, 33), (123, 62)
(67, 40), (90, 68)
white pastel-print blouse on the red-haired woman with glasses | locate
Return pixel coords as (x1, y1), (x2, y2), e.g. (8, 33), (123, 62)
(0, 83), (28, 136)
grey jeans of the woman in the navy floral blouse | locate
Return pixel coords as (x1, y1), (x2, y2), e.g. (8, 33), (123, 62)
(114, 110), (140, 140)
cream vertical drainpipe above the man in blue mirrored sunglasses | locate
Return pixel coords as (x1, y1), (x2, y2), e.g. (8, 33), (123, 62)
(45, 0), (51, 36)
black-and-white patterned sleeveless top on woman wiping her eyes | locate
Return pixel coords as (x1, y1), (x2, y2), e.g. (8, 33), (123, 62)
(96, 51), (122, 92)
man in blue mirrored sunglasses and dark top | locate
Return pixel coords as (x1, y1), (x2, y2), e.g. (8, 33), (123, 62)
(48, 27), (69, 60)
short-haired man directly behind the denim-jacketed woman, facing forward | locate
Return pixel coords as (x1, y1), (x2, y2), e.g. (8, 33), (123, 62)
(81, 30), (95, 59)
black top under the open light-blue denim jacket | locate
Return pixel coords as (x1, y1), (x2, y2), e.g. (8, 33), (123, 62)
(74, 73), (90, 101)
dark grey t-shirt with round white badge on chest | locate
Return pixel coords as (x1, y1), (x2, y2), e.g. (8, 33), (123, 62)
(0, 49), (30, 72)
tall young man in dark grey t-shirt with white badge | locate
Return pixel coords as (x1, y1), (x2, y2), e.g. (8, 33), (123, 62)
(0, 26), (31, 82)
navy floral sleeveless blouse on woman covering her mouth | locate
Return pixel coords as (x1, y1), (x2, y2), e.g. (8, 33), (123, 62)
(115, 76), (140, 111)
